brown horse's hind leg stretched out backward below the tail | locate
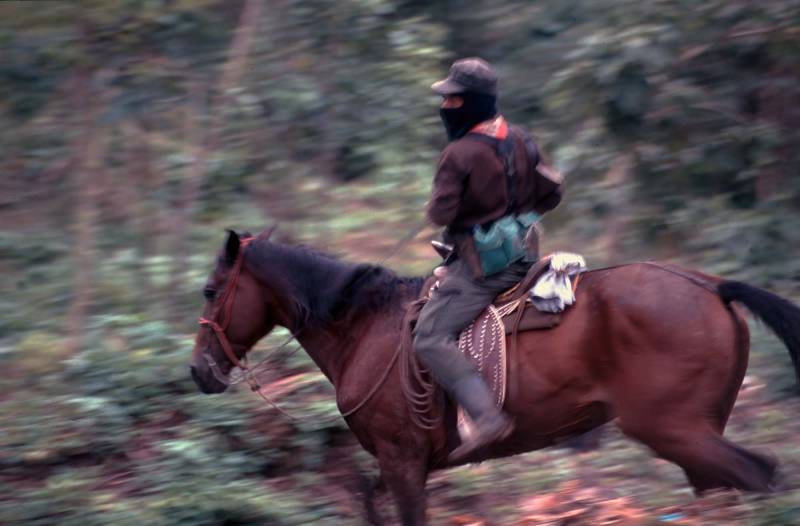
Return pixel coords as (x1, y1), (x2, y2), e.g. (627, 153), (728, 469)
(620, 422), (777, 493)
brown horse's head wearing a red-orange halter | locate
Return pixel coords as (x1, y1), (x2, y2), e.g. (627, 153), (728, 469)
(189, 231), (275, 394)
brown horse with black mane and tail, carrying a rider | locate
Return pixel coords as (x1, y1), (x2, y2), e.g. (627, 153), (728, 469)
(191, 232), (800, 524)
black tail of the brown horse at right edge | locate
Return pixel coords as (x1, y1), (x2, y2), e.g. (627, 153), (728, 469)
(717, 281), (800, 382)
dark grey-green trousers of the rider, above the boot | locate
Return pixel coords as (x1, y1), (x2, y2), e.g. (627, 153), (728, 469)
(414, 261), (530, 396)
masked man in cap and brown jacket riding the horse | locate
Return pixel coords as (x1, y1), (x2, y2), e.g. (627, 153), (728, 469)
(414, 58), (562, 463)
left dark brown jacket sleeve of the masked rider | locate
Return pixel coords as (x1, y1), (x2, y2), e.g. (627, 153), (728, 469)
(427, 145), (469, 226)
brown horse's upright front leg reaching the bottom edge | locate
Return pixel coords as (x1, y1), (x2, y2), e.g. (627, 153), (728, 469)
(377, 443), (428, 526)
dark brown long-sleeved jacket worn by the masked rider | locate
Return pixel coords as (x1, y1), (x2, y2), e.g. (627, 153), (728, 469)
(427, 126), (562, 231)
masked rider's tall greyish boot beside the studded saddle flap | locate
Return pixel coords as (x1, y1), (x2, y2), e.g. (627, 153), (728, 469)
(447, 374), (514, 464)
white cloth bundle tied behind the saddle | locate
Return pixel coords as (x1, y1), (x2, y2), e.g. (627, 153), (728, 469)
(528, 252), (586, 312)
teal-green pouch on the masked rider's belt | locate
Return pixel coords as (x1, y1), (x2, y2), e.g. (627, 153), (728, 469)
(472, 212), (539, 276)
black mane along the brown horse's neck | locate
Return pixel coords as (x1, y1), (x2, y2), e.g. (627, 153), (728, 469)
(248, 240), (425, 325)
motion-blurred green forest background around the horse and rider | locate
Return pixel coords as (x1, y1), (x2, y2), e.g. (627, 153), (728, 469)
(0, 0), (800, 526)
